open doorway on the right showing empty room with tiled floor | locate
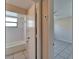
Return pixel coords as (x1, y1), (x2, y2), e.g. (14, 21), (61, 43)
(54, 0), (73, 59)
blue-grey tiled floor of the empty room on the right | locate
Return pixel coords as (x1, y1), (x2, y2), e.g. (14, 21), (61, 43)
(54, 40), (72, 59)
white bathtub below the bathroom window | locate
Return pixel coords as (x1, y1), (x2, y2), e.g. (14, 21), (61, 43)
(6, 41), (27, 55)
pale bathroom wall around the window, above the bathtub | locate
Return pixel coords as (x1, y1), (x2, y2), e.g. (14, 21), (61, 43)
(6, 15), (24, 44)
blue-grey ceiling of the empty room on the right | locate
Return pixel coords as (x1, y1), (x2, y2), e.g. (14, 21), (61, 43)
(54, 0), (72, 19)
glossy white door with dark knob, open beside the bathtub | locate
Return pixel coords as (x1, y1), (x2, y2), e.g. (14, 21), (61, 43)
(26, 5), (35, 59)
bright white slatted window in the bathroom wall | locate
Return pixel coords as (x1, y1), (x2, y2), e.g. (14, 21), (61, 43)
(6, 11), (18, 27)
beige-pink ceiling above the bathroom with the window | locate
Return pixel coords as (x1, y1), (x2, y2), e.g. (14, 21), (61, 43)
(6, 0), (33, 9)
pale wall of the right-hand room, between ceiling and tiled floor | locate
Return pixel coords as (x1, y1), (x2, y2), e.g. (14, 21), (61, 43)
(54, 17), (72, 42)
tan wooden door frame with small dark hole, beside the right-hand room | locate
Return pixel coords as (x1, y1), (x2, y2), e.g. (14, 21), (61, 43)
(41, 0), (54, 59)
